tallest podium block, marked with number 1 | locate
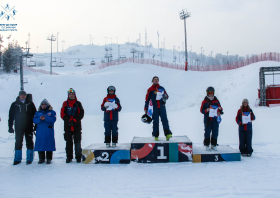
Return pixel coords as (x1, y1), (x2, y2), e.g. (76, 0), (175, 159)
(131, 136), (193, 163)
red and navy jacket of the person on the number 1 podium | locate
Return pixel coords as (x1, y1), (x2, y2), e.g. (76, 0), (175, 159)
(144, 84), (169, 110)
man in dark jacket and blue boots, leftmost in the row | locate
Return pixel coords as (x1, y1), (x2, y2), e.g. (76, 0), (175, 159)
(8, 91), (36, 165)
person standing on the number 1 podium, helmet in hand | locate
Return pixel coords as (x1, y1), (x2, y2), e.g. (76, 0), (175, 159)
(144, 76), (172, 141)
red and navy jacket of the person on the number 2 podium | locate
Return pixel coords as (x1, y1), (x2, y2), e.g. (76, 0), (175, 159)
(101, 94), (122, 121)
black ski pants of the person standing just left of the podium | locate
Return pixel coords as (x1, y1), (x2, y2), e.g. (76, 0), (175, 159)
(64, 131), (82, 159)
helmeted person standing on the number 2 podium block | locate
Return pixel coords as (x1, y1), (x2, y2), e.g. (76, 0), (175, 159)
(101, 86), (122, 147)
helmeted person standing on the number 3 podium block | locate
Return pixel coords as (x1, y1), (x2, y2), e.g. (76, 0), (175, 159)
(200, 87), (223, 151)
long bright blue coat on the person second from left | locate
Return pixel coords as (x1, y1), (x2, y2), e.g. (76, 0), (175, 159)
(33, 106), (56, 151)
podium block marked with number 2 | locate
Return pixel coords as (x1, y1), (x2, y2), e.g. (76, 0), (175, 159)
(82, 143), (130, 164)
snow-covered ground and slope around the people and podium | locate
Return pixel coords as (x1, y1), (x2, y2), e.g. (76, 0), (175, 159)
(0, 62), (280, 197)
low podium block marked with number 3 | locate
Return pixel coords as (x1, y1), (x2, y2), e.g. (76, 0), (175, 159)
(193, 145), (241, 163)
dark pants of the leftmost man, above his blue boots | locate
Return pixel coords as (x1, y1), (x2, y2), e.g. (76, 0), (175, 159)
(15, 130), (34, 150)
